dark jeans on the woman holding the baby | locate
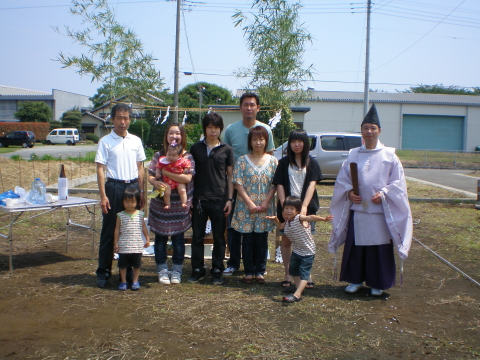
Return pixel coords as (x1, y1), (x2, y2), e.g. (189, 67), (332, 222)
(154, 233), (185, 274)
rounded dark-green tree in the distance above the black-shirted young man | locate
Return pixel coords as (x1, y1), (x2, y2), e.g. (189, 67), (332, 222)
(178, 81), (236, 123)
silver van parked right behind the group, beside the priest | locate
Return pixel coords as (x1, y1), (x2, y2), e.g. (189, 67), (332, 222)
(273, 132), (362, 179)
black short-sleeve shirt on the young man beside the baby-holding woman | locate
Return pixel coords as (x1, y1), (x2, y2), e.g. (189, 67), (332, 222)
(190, 140), (234, 202)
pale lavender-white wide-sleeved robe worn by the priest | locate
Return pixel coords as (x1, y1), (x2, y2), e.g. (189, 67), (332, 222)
(328, 141), (413, 259)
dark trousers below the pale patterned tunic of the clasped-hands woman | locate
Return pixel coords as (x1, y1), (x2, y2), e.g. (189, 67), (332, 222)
(242, 231), (268, 276)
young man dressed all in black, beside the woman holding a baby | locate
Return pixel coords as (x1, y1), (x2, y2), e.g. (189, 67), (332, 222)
(188, 113), (233, 285)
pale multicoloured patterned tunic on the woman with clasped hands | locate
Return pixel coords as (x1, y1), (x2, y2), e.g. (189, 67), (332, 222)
(232, 155), (278, 233)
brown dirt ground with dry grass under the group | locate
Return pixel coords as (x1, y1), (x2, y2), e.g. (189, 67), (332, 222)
(0, 160), (480, 359)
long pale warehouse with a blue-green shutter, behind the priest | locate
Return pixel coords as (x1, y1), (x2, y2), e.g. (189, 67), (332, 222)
(216, 90), (480, 151)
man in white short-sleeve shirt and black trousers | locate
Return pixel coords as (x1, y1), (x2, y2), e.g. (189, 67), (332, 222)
(95, 104), (145, 288)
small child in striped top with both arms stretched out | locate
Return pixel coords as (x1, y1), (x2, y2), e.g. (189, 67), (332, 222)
(266, 196), (333, 303)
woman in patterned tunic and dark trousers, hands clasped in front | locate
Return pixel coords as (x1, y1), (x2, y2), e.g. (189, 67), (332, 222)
(232, 126), (277, 284)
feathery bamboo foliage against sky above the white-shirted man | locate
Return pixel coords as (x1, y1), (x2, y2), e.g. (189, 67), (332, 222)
(55, 0), (163, 99)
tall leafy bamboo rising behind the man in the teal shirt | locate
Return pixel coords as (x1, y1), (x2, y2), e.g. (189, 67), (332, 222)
(232, 0), (313, 144)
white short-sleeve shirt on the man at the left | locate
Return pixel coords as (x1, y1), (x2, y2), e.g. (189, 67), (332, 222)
(95, 130), (146, 180)
